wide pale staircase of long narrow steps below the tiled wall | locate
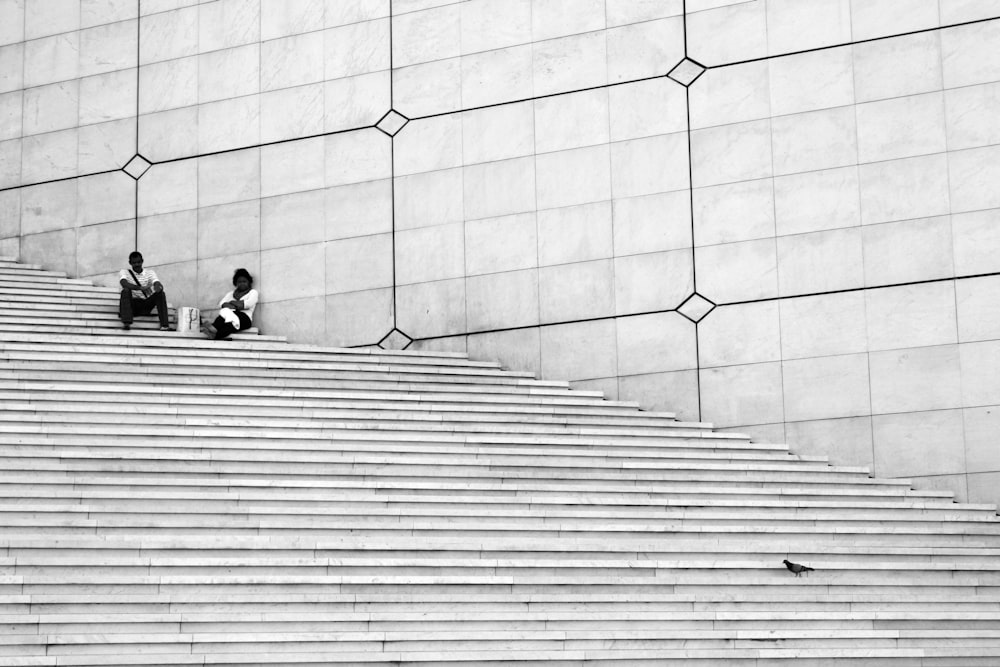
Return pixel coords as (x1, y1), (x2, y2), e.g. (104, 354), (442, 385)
(0, 254), (1000, 667)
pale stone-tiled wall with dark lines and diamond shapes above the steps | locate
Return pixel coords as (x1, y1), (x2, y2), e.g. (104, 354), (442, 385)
(0, 0), (1000, 502)
